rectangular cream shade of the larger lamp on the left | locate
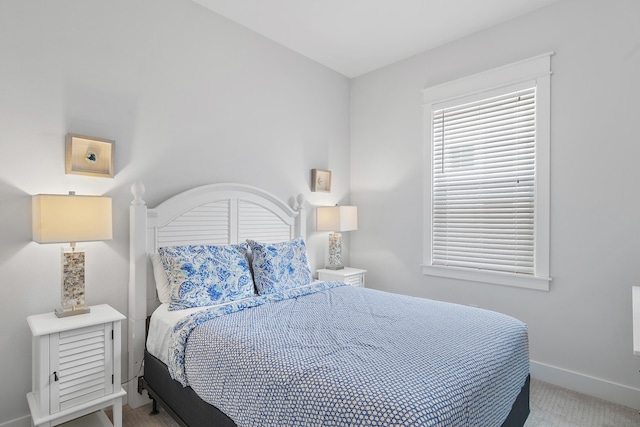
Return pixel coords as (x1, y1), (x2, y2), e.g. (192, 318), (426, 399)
(32, 194), (112, 243)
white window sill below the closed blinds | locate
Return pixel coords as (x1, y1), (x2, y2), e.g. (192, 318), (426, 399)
(422, 264), (551, 291)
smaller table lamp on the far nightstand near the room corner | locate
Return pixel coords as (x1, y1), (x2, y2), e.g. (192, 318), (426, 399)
(316, 205), (358, 270)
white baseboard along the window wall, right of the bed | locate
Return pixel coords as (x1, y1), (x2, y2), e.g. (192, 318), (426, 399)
(530, 360), (640, 409)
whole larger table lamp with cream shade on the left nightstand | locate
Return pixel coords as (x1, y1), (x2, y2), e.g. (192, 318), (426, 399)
(32, 192), (112, 317)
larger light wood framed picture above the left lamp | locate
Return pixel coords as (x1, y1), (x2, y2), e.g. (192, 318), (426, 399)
(65, 133), (115, 178)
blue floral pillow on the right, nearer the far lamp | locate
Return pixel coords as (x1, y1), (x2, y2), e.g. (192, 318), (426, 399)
(247, 239), (313, 295)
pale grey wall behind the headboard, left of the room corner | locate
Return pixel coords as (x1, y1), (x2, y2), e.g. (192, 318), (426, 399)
(0, 0), (349, 424)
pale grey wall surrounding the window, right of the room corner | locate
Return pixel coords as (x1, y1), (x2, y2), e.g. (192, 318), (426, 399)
(351, 0), (640, 408)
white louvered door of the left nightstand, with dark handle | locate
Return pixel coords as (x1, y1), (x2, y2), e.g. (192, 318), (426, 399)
(49, 323), (113, 413)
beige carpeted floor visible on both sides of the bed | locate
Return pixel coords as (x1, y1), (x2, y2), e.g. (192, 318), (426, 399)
(109, 379), (640, 427)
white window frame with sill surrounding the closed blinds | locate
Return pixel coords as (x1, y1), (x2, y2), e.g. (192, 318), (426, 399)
(422, 52), (553, 291)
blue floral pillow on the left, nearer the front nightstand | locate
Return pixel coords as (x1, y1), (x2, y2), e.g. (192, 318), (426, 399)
(158, 244), (255, 310)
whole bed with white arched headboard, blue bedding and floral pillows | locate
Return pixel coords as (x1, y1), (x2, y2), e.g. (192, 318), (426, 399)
(129, 184), (529, 426)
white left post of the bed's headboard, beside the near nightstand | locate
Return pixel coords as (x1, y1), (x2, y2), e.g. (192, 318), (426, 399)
(127, 183), (149, 408)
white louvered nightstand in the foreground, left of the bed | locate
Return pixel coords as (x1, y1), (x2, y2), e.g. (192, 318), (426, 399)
(27, 304), (126, 427)
